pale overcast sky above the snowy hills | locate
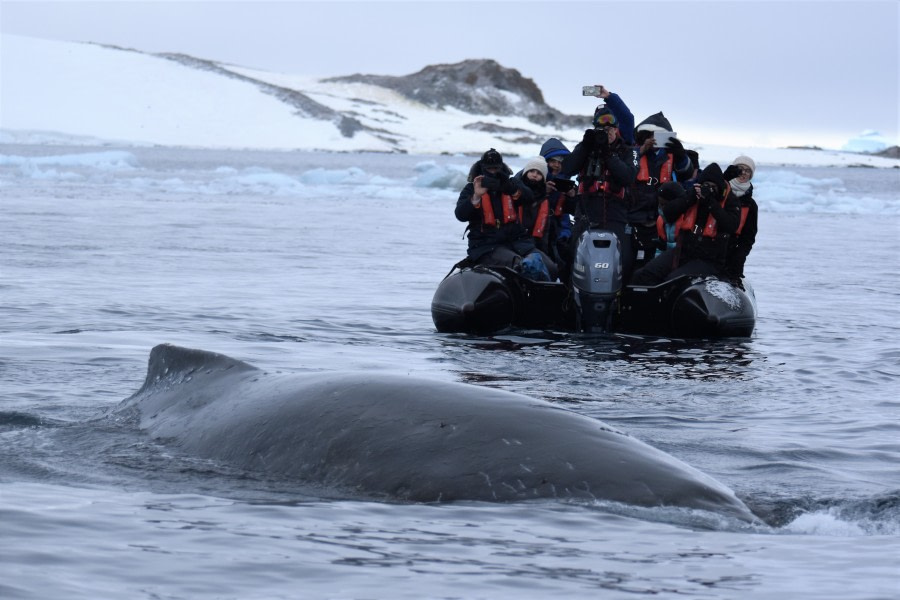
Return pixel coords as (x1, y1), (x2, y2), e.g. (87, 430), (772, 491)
(0, 0), (900, 148)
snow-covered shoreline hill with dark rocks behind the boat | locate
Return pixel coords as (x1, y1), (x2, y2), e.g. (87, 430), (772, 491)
(0, 35), (900, 167)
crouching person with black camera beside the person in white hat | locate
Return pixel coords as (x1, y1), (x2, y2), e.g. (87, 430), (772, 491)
(631, 163), (740, 286)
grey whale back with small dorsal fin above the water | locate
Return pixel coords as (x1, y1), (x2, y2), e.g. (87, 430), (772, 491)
(111, 344), (758, 522)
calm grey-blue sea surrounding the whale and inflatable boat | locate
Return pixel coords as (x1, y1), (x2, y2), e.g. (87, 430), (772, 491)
(0, 145), (900, 600)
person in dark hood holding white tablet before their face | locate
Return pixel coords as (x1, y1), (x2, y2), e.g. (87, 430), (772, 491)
(628, 112), (694, 269)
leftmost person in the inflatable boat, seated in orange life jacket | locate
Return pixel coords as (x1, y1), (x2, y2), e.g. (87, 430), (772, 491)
(455, 148), (549, 279)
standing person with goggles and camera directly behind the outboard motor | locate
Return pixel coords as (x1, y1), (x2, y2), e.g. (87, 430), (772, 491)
(562, 105), (637, 279)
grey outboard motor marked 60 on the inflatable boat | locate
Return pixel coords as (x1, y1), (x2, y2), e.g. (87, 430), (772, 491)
(572, 229), (622, 332)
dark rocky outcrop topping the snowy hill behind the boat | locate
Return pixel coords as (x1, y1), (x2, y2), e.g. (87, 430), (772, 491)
(325, 59), (588, 127)
